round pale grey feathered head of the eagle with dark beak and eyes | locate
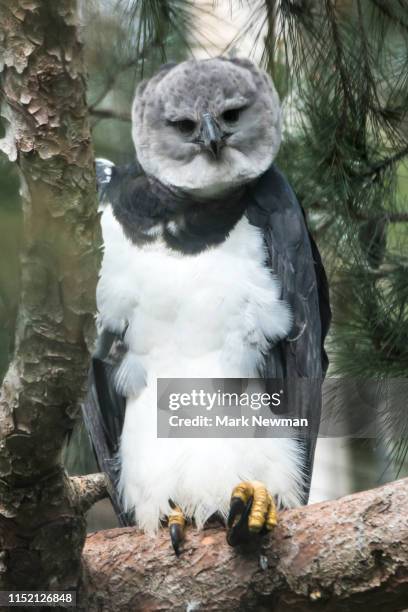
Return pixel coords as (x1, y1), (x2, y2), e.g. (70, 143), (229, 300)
(132, 58), (281, 196)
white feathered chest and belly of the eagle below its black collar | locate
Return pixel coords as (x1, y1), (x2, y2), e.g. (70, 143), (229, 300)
(97, 209), (302, 531)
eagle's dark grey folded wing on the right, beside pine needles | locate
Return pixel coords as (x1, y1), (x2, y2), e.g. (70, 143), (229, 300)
(247, 166), (331, 503)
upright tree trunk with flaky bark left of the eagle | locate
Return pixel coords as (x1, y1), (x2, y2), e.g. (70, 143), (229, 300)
(0, 0), (100, 589)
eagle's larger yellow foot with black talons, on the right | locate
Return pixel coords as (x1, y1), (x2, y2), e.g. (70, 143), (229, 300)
(227, 480), (278, 546)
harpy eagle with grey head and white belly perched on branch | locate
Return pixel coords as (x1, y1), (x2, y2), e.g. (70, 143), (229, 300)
(84, 57), (330, 553)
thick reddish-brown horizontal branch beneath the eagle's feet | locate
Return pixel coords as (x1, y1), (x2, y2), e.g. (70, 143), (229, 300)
(80, 479), (408, 612)
